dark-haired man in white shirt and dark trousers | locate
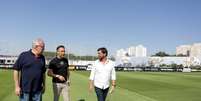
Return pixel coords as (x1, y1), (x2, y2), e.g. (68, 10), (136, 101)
(89, 47), (116, 101)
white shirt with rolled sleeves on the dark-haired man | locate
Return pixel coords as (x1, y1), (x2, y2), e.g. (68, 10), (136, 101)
(89, 59), (116, 89)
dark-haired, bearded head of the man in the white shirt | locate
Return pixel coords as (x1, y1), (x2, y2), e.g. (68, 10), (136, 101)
(97, 47), (108, 60)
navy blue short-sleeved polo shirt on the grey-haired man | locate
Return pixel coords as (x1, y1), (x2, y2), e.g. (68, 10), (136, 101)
(13, 50), (46, 93)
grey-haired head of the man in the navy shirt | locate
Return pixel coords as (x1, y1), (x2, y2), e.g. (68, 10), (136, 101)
(32, 38), (45, 55)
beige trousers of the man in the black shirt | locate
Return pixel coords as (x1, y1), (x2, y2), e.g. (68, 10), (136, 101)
(53, 83), (70, 101)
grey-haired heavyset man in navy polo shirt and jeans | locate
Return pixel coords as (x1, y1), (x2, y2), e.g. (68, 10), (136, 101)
(13, 39), (46, 101)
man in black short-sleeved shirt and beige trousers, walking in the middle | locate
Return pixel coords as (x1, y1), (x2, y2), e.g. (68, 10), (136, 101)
(48, 45), (70, 101)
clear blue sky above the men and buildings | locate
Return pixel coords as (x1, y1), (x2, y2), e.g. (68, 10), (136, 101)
(0, 0), (201, 55)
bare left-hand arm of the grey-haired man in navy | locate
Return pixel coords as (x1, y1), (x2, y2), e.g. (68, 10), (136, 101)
(13, 70), (21, 96)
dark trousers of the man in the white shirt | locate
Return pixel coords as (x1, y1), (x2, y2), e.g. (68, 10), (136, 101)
(95, 87), (109, 101)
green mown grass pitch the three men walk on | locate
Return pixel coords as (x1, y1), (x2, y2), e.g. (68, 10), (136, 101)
(0, 70), (201, 101)
